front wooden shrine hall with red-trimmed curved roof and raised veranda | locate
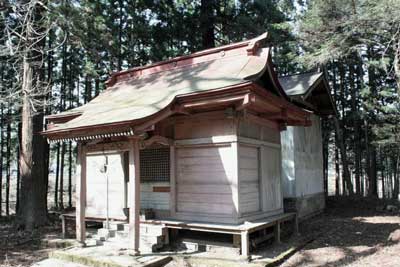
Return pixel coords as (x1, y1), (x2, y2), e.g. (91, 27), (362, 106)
(43, 34), (311, 256)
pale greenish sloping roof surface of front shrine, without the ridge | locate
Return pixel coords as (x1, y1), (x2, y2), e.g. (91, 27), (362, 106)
(49, 49), (268, 132)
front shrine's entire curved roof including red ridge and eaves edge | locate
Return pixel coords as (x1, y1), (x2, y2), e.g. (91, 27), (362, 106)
(43, 34), (310, 139)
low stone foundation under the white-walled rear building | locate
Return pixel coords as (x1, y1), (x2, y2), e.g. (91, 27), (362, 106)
(283, 193), (325, 220)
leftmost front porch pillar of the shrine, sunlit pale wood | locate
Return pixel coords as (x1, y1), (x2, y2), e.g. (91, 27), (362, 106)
(75, 144), (86, 245)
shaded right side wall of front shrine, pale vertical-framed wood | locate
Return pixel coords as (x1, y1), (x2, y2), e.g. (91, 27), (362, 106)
(238, 120), (283, 220)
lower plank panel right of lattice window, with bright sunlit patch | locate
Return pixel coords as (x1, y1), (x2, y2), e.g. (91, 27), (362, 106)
(176, 145), (236, 218)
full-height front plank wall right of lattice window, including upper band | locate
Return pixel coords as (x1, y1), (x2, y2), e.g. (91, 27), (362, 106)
(175, 112), (238, 223)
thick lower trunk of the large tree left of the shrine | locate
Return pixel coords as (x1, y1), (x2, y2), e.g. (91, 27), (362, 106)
(18, 56), (47, 230)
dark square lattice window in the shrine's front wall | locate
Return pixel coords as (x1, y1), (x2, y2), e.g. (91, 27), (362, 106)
(140, 147), (170, 182)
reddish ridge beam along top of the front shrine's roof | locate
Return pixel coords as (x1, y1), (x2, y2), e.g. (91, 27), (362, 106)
(106, 32), (268, 87)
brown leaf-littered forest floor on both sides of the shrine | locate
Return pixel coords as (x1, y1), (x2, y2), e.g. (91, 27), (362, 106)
(0, 199), (400, 267)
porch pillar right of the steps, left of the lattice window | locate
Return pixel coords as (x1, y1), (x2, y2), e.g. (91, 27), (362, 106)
(129, 138), (140, 255)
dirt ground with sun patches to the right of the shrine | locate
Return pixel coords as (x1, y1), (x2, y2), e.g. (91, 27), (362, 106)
(280, 199), (400, 267)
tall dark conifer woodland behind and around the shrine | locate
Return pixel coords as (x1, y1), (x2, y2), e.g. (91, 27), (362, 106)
(0, 0), (400, 228)
